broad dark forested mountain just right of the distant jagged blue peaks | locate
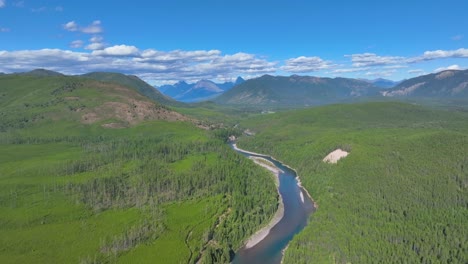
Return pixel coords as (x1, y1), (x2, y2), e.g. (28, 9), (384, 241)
(215, 75), (380, 107)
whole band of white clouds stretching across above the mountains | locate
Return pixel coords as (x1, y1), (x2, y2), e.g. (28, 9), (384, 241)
(0, 45), (464, 83)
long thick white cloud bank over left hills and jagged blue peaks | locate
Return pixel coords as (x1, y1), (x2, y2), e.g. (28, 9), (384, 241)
(0, 45), (277, 83)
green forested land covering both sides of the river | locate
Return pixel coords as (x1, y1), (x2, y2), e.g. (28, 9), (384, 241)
(0, 71), (468, 263)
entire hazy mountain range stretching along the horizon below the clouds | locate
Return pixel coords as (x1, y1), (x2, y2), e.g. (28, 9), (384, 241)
(2, 69), (468, 108)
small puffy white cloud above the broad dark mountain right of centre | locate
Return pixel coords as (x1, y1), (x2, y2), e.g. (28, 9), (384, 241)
(281, 56), (332, 73)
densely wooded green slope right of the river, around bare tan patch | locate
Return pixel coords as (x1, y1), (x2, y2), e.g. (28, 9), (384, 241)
(240, 103), (468, 263)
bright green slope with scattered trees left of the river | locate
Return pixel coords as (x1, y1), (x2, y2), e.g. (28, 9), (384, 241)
(0, 76), (276, 263)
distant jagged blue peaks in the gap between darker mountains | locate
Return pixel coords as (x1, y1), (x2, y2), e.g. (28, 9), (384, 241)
(156, 77), (244, 103)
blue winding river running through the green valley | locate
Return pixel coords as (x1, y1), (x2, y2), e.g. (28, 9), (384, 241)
(231, 143), (315, 264)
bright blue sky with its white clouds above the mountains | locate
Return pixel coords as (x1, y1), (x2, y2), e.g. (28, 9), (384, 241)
(0, 0), (468, 84)
